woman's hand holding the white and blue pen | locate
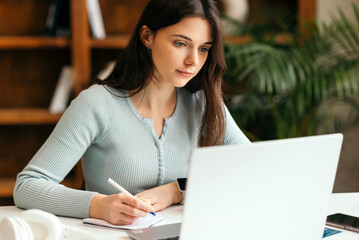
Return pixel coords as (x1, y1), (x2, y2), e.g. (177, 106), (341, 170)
(89, 193), (155, 225)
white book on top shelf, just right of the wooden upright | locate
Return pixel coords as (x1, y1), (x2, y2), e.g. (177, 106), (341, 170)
(86, 0), (106, 39)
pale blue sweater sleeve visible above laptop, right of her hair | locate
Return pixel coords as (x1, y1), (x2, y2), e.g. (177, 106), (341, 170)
(223, 106), (250, 144)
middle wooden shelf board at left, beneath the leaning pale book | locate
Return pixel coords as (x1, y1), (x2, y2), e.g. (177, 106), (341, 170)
(0, 108), (61, 125)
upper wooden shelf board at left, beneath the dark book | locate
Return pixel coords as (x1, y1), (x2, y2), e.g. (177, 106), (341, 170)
(0, 36), (70, 49)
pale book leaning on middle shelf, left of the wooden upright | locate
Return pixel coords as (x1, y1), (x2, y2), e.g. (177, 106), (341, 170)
(49, 66), (73, 114)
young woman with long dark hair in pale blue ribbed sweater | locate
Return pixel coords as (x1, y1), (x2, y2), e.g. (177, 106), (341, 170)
(14, 0), (249, 224)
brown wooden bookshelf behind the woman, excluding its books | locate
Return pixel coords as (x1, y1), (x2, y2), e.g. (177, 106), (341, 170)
(0, 0), (315, 198)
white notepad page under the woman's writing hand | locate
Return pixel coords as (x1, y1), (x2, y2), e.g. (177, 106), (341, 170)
(82, 214), (163, 229)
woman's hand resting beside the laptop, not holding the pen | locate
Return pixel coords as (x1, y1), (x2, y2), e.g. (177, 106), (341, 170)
(136, 182), (182, 211)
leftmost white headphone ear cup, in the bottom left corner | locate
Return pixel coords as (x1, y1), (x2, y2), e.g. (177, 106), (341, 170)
(0, 217), (34, 240)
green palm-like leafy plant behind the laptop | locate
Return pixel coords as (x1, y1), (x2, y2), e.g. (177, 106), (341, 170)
(223, 5), (359, 140)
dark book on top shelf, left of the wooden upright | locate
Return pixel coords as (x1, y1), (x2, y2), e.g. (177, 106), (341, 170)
(45, 0), (70, 37)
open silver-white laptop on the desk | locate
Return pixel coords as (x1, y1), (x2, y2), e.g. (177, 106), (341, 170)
(127, 134), (343, 240)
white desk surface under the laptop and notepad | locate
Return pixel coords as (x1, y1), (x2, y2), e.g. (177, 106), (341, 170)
(0, 193), (359, 240)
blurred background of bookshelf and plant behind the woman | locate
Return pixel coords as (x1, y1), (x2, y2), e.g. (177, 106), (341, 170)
(0, 0), (359, 205)
